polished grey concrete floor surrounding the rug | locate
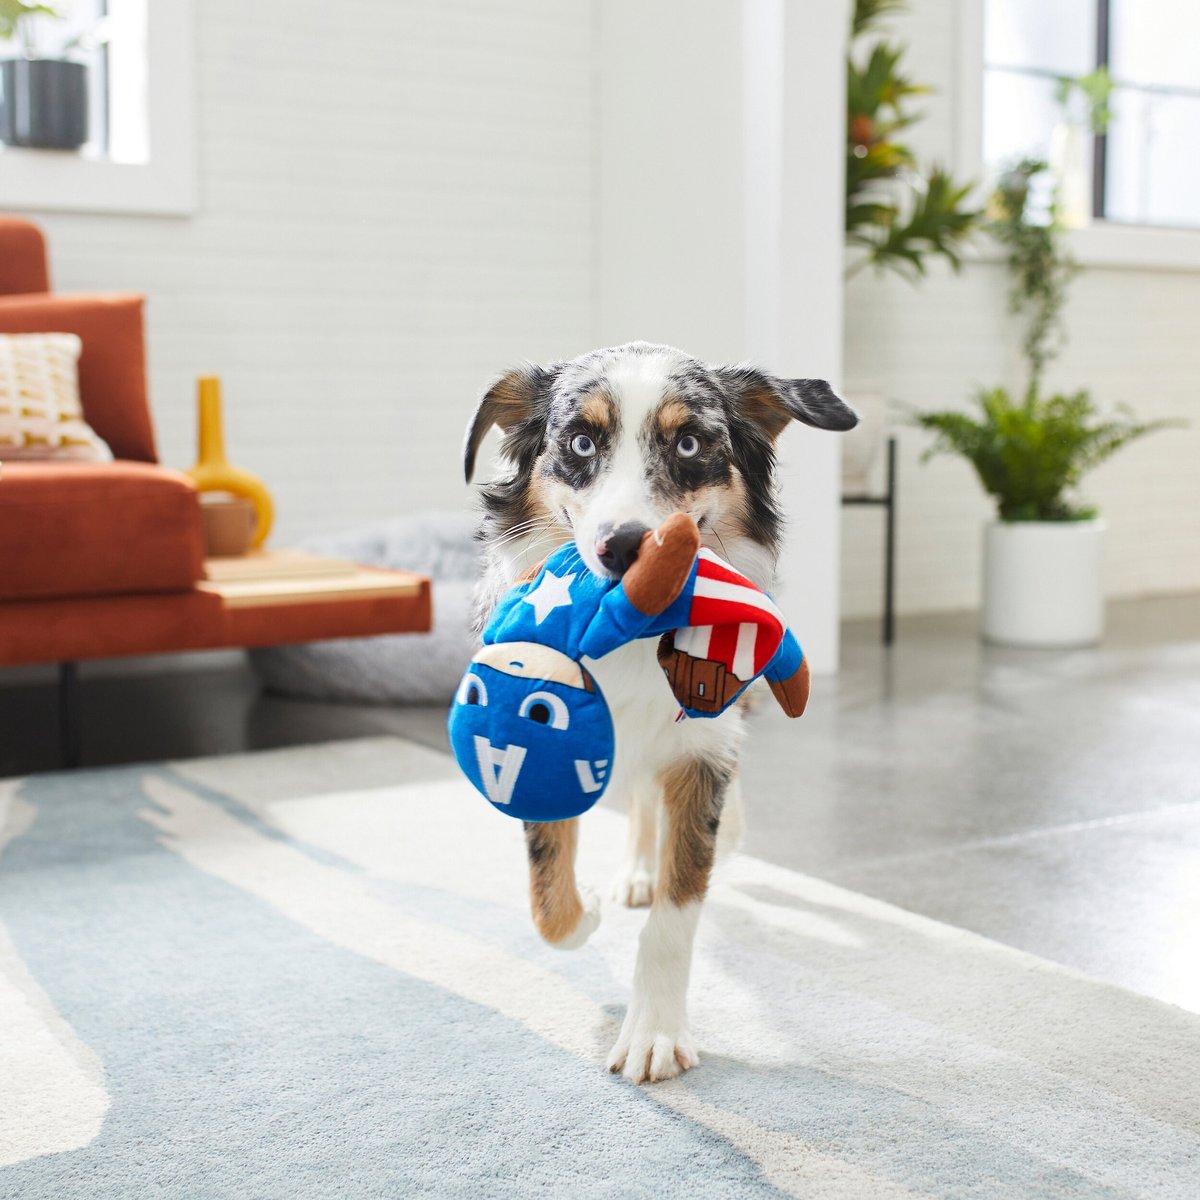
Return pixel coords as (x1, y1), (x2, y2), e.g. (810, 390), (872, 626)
(0, 596), (1200, 1012)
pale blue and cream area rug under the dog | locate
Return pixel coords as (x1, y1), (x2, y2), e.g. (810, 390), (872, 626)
(0, 738), (1200, 1200)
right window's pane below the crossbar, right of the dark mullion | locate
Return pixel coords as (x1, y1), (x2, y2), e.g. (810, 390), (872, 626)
(1105, 88), (1200, 226)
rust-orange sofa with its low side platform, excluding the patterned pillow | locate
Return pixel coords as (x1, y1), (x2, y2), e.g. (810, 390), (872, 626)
(0, 216), (431, 756)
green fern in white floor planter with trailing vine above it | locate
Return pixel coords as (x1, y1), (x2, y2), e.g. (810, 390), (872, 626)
(913, 160), (1177, 647)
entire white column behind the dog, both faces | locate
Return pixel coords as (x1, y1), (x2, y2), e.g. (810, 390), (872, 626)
(596, 0), (848, 671)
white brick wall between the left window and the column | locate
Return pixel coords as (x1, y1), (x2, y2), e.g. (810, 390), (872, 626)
(28, 0), (593, 540)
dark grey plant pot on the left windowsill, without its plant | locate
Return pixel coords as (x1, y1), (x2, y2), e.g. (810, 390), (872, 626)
(0, 59), (88, 150)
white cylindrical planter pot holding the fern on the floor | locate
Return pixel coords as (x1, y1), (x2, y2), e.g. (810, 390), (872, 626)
(983, 521), (1105, 646)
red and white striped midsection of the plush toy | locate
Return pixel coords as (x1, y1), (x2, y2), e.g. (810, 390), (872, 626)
(674, 547), (787, 679)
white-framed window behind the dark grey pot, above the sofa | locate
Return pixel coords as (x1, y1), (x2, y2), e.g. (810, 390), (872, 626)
(0, 0), (196, 215)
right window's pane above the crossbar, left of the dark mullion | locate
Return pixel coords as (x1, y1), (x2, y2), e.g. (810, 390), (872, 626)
(984, 0), (1099, 74)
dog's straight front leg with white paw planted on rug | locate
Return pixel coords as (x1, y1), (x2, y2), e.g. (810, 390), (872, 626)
(608, 758), (733, 1084)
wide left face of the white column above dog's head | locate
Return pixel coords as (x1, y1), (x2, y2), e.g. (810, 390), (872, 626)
(596, 0), (745, 361)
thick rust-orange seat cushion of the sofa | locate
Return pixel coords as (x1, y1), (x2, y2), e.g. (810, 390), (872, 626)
(0, 462), (204, 604)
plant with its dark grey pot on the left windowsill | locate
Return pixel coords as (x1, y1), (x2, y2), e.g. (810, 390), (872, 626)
(0, 0), (88, 150)
